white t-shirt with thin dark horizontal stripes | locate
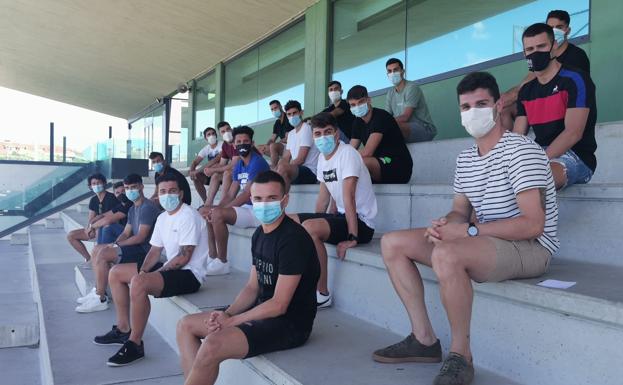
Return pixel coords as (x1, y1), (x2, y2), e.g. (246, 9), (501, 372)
(454, 132), (560, 254)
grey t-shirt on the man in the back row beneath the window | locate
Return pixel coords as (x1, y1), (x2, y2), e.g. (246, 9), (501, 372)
(385, 80), (435, 127)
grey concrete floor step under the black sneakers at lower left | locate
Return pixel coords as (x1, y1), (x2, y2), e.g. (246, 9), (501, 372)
(30, 222), (183, 385)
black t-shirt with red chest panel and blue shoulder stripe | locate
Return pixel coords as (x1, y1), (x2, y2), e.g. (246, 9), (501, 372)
(517, 66), (597, 171)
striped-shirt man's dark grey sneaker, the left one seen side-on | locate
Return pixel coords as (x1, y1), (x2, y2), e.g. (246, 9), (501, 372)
(372, 333), (441, 364)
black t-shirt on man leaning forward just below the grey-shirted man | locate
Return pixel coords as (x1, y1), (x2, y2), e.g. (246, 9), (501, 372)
(352, 108), (413, 167)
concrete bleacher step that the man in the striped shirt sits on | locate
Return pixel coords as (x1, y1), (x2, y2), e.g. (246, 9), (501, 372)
(229, 227), (623, 384)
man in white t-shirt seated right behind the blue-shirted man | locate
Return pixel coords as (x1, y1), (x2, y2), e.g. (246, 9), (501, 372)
(277, 100), (319, 191)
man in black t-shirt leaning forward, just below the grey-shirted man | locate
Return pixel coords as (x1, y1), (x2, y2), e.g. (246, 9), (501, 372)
(346, 85), (413, 183)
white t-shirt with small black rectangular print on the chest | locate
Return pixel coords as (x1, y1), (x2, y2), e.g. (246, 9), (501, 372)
(314, 142), (377, 229)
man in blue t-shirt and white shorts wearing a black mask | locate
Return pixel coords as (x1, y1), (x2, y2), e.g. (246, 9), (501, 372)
(199, 126), (270, 275)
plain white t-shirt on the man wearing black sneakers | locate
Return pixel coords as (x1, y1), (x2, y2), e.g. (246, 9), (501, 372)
(150, 203), (208, 283)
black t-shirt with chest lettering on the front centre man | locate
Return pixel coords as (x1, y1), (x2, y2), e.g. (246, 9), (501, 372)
(251, 216), (320, 331)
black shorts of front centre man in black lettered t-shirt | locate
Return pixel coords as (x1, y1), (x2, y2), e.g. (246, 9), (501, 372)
(237, 317), (311, 358)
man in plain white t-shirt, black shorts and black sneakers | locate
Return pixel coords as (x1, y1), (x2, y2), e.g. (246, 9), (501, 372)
(93, 174), (208, 367)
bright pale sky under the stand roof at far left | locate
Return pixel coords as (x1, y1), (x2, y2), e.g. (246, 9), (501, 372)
(0, 87), (128, 151)
